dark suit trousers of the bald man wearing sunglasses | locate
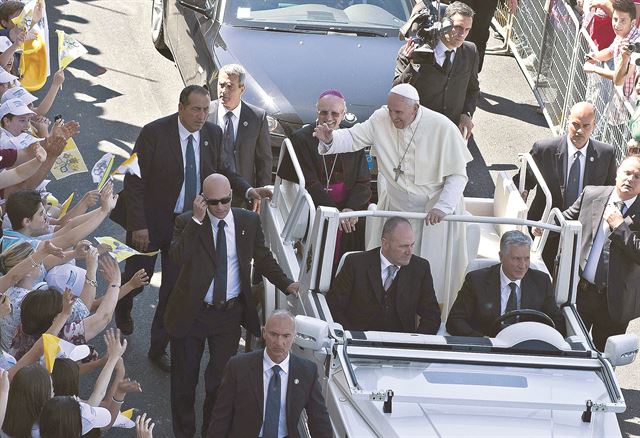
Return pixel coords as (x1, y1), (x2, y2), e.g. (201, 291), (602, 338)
(171, 301), (243, 438)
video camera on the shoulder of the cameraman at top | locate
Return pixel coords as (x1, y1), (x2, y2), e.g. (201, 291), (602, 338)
(400, 1), (453, 64)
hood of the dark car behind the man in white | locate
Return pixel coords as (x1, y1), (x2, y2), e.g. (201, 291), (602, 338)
(215, 25), (402, 123)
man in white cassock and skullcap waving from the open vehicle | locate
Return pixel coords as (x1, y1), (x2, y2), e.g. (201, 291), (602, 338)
(314, 84), (472, 315)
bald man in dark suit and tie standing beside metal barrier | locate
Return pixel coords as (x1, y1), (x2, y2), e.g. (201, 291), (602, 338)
(513, 102), (616, 272)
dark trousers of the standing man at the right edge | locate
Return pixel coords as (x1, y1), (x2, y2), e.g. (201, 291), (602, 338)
(576, 280), (629, 351)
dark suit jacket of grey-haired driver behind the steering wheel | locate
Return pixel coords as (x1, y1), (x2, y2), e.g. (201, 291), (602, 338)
(447, 263), (565, 336)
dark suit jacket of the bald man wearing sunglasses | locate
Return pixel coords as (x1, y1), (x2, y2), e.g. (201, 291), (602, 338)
(164, 208), (293, 338)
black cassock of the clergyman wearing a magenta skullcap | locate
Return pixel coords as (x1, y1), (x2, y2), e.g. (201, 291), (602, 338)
(278, 125), (371, 211)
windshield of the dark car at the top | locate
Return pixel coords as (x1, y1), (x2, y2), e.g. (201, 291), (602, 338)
(226, 0), (412, 30)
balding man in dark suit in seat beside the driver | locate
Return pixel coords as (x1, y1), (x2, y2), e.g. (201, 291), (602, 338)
(327, 217), (440, 334)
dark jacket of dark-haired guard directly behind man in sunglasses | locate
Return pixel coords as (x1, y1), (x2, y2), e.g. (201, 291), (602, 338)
(111, 113), (250, 249)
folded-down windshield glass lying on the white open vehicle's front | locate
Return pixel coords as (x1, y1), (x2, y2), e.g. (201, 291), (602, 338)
(349, 352), (610, 404)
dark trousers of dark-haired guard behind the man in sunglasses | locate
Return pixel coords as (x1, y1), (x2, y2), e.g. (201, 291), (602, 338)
(115, 232), (180, 357)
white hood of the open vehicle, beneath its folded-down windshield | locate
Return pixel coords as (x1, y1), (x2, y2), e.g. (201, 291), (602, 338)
(340, 364), (620, 438)
